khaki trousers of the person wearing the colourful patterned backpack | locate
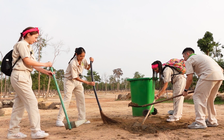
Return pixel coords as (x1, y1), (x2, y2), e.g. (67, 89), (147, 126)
(173, 75), (186, 119)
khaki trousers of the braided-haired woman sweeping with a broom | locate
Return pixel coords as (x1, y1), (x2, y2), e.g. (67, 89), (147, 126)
(57, 78), (86, 121)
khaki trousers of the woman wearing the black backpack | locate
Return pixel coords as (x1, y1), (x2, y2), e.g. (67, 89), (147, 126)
(8, 70), (41, 134)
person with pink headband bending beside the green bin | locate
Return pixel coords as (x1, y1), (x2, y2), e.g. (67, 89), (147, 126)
(152, 61), (186, 122)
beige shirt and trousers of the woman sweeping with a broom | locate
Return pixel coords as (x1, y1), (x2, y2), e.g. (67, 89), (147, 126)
(58, 57), (88, 121)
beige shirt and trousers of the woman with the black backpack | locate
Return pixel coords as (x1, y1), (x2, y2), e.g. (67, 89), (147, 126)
(8, 40), (41, 134)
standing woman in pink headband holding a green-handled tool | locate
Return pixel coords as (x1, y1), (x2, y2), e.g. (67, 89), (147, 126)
(7, 27), (52, 139)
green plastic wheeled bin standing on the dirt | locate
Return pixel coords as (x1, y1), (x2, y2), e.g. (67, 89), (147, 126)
(127, 78), (155, 116)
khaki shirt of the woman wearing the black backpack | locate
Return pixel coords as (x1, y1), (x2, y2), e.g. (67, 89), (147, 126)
(12, 40), (36, 72)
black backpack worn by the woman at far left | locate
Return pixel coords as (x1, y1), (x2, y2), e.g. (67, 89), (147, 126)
(1, 50), (21, 76)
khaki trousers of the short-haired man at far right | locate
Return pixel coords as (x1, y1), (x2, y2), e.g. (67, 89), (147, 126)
(193, 79), (222, 126)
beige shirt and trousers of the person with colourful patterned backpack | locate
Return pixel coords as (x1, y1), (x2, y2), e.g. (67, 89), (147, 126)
(163, 67), (186, 119)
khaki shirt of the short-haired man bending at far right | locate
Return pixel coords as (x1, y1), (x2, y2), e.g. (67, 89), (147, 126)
(185, 54), (223, 80)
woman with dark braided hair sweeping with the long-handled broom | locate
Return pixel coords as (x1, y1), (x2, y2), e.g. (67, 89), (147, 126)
(56, 47), (95, 127)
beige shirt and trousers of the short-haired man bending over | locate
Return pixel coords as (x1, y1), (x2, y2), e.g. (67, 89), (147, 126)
(185, 55), (223, 126)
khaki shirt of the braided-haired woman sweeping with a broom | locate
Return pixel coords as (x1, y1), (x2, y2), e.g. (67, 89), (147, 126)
(64, 57), (88, 80)
